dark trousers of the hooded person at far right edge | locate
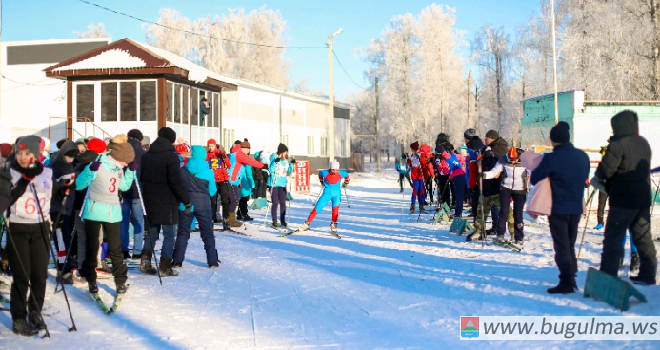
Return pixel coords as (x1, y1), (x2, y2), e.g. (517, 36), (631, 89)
(600, 206), (658, 280)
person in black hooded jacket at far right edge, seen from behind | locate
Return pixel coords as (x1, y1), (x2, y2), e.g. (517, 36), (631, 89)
(592, 111), (658, 284)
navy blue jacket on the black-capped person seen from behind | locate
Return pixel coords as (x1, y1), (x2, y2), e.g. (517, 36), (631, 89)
(530, 142), (589, 215)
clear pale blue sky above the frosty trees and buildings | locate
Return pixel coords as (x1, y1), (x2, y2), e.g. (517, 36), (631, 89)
(2, 0), (540, 99)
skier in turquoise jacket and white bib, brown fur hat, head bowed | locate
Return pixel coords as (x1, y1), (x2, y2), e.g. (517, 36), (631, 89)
(76, 135), (137, 293)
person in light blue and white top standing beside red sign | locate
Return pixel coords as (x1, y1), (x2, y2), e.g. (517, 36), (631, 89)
(268, 143), (295, 228)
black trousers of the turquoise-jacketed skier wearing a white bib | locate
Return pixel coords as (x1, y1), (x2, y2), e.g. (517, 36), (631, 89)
(80, 220), (127, 286)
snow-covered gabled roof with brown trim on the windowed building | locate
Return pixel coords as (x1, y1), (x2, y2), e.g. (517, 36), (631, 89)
(44, 39), (237, 90)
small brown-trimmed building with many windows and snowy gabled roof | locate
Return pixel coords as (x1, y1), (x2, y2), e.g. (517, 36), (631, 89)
(44, 39), (237, 144)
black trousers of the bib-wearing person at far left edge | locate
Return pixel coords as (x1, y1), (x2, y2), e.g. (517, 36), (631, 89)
(5, 223), (49, 320)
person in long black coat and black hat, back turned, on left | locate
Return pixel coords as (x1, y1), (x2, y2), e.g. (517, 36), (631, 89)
(140, 127), (191, 274)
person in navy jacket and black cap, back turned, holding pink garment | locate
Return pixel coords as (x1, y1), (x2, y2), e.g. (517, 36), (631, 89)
(530, 121), (592, 294)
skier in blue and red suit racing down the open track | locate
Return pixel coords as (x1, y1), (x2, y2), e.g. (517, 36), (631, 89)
(298, 160), (350, 235)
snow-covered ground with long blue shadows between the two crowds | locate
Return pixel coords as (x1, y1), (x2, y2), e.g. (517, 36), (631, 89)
(0, 165), (660, 349)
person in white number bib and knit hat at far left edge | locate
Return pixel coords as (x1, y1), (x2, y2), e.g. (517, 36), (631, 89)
(0, 136), (65, 336)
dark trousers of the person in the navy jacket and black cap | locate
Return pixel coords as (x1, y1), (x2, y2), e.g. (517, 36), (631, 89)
(548, 214), (580, 285)
